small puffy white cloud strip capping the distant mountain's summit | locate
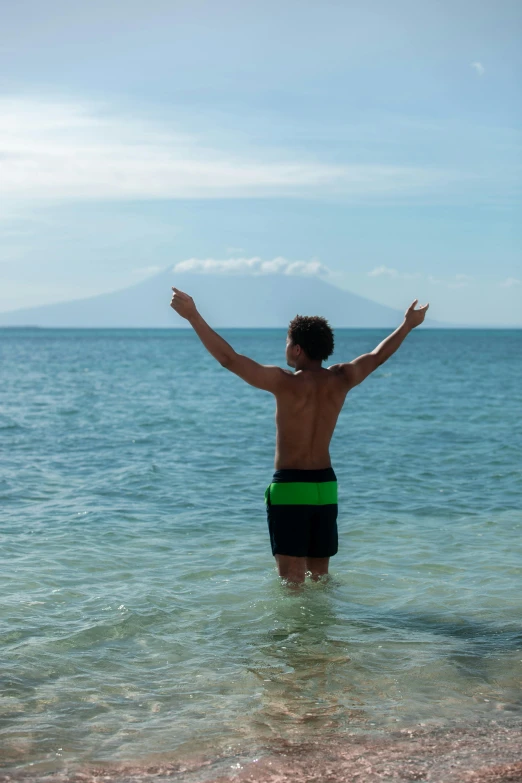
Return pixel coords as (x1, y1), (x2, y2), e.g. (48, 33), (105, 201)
(172, 256), (331, 277)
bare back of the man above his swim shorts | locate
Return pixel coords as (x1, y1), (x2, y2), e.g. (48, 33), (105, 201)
(275, 365), (349, 470)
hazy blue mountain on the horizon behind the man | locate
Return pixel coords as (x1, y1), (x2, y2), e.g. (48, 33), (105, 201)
(0, 267), (443, 328)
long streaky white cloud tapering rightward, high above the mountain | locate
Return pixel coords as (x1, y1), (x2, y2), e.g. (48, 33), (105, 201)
(0, 98), (456, 202)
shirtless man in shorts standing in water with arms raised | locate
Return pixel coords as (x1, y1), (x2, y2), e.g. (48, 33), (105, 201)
(170, 287), (429, 583)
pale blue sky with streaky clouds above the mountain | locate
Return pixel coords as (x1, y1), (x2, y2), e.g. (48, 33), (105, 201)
(0, 0), (522, 326)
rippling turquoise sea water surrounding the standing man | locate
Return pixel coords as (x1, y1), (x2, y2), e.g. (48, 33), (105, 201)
(0, 329), (522, 772)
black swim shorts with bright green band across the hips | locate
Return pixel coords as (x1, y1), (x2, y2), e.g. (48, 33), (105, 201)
(265, 468), (337, 557)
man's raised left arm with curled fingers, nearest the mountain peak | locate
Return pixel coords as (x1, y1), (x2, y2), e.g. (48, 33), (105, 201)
(170, 286), (288, 394)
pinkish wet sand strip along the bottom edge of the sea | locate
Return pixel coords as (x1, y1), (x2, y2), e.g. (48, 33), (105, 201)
(4, 718), (522, 783)
